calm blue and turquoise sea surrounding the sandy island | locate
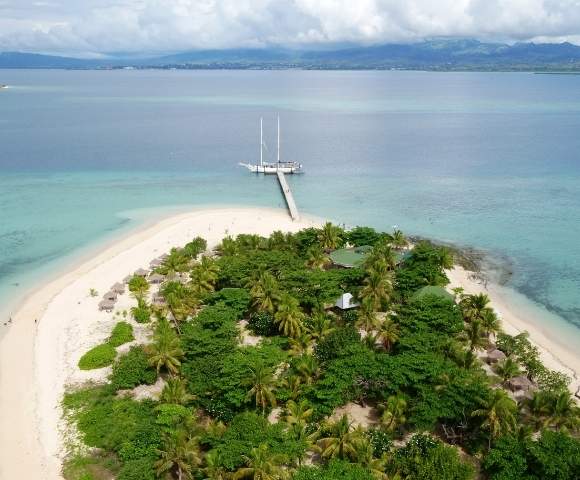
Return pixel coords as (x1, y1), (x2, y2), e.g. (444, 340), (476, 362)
(0, 70), (580, 346)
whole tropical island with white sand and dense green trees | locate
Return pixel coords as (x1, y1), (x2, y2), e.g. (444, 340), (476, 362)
(0, 208), (580, 480)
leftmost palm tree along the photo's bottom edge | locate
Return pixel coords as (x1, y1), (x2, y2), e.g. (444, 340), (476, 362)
(155, 429), (201, 480)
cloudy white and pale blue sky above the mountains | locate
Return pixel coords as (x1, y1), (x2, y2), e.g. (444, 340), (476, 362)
(0, 0), (580, 57)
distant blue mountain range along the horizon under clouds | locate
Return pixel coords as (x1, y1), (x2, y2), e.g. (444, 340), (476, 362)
(0, 40), (580, 72)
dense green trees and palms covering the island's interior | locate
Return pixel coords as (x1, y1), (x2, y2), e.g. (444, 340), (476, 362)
(64, 224), (580, 480)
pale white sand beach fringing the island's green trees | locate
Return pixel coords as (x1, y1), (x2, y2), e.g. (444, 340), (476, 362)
(0, 204), (580, 480)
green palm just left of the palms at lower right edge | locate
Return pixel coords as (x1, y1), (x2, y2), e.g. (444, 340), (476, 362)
(471, 389), (517, 449)
